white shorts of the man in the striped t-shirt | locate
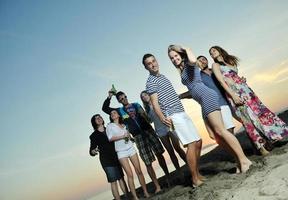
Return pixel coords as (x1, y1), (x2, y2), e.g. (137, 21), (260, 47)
(169, 112), (201, 146)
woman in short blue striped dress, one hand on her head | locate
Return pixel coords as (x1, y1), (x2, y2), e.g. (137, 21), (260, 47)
(168, 45), (252, 173)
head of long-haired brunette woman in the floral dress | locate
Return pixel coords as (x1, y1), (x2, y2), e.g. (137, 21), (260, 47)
(209, 46), (239, 66)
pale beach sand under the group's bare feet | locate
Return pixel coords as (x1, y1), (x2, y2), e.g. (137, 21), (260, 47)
(132, 110), (288, 200)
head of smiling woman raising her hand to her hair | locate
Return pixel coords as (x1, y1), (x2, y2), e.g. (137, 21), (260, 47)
(168, 45), (187, 68)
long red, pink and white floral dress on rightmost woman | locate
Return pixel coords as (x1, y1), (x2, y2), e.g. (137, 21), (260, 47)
(220, 65), (288, 149)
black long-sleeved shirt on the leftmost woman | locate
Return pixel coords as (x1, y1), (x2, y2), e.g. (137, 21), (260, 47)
(89, 129), (120, 167)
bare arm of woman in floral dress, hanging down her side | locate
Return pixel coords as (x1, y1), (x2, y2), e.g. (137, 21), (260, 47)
(212, 63), (243, 105)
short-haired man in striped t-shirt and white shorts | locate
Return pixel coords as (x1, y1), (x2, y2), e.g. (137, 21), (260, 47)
(142, 54), (203, 186)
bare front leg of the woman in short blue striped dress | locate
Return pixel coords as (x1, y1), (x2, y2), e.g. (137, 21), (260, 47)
(207, 110), (252, 173)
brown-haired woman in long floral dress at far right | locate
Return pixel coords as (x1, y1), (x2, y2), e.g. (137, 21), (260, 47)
(209, 46), (288, 155)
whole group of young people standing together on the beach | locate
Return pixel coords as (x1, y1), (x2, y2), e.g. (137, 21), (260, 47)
(90, 45), (288, 199)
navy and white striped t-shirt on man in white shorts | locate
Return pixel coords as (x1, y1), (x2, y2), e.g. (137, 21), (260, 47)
(146, 74), (184, 117)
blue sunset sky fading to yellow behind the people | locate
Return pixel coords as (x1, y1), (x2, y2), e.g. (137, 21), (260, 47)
(0, 0), (288, 200)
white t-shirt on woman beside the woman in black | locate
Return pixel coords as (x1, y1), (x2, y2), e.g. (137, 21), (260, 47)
(106, 123), (133, 152)
